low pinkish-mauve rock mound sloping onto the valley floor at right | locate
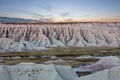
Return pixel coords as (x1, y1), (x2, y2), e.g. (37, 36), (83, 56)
(82, 56), (120, 72)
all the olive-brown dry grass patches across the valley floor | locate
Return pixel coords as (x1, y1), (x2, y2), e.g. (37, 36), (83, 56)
(0, 47), (120, 67)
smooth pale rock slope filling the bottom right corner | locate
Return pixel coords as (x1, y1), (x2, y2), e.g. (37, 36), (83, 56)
(78, 66), (120, 80)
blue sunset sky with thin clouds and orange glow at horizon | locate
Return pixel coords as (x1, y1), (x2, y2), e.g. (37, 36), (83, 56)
(0, 0), (120, 22)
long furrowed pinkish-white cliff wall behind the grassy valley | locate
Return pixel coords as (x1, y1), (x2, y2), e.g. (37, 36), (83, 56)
(0, 23), (120, 50)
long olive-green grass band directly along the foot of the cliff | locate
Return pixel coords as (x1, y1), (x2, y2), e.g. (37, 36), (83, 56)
(0, 47), (120, 58)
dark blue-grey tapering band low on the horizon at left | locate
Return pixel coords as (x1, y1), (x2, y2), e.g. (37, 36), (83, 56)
(0, 17), (38, 23)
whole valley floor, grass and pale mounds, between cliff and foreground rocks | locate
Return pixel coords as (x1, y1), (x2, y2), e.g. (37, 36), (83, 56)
(0, 47), (120, 76)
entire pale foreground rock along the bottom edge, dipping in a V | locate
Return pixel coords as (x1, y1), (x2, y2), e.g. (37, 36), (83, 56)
(0, 63), (120, 80)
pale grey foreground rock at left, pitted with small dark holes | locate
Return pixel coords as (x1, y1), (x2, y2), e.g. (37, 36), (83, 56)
(0, 63), (77, 80)
